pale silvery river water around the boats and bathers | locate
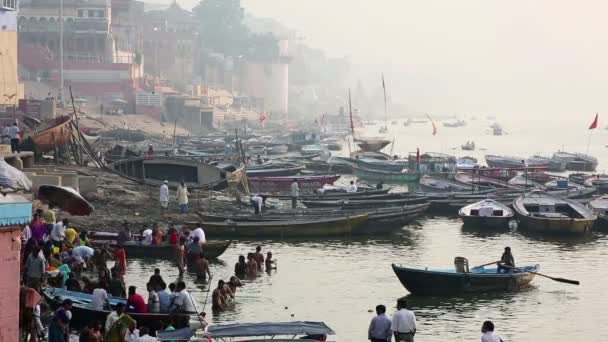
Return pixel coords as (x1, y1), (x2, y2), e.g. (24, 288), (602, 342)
(119, 118), (608, 342)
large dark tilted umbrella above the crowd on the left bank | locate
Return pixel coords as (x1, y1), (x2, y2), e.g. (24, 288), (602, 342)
(38, 185), (94, 216)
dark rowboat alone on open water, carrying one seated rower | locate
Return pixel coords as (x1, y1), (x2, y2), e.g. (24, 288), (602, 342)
(392, 264), (540, 296)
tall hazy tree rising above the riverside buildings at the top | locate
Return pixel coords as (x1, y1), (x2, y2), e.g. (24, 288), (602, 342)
(193, 0), (249, 56)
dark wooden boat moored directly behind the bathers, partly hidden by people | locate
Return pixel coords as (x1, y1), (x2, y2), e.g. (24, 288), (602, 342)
(122, 241), (232, 260)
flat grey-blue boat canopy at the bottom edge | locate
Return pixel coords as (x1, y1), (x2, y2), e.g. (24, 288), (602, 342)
(207, 321), (334, 337)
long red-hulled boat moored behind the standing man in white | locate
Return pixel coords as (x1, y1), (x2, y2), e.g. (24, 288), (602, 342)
(249, 175), (340, 194)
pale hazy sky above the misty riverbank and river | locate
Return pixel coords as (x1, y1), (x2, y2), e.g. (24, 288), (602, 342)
(164, 0), (608, 118)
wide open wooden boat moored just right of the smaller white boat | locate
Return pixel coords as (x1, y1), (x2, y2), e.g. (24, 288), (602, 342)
(513, 191), (597, 234)
